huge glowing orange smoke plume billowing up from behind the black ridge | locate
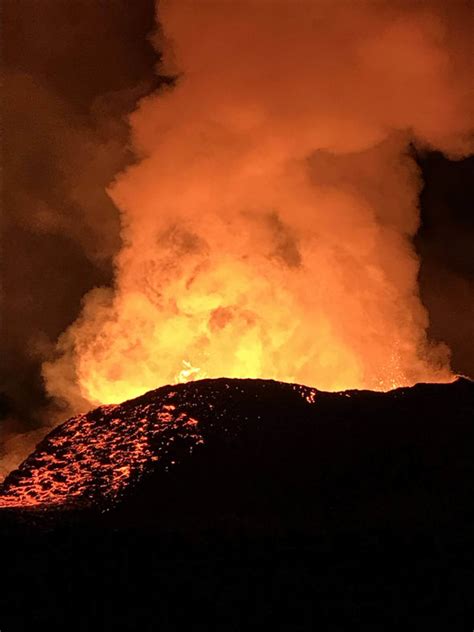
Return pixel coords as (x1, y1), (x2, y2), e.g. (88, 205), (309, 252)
(43, 0), (472, 409)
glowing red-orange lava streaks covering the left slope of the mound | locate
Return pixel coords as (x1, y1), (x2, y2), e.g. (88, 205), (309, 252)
(0, 381), (315, 507)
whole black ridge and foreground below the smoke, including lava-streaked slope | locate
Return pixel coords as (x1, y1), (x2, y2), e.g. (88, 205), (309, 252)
(0, 378), (474, 630)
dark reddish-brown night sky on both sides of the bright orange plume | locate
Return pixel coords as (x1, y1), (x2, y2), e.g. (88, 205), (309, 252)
(0, 0), (474, 429)
